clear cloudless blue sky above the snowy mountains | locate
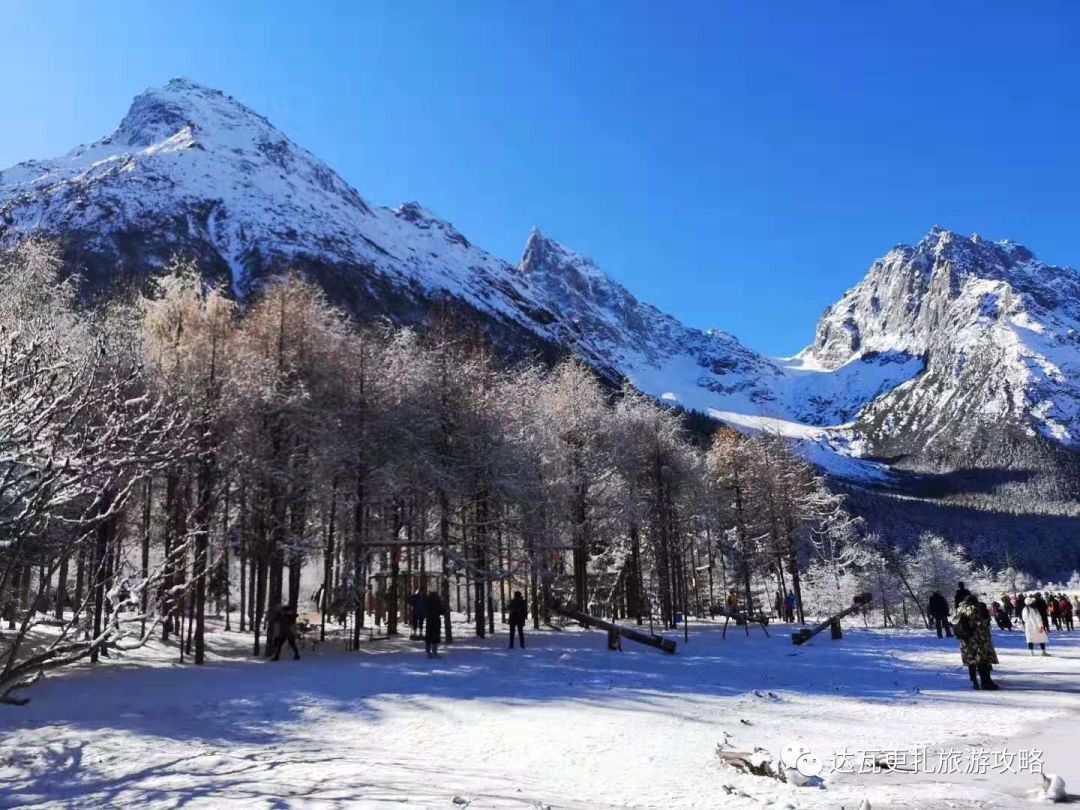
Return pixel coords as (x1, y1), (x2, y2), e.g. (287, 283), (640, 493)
(0, 0), (1080, 353)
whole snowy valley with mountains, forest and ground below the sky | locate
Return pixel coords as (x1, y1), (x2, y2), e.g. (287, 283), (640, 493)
(6, 80), (1080, 810)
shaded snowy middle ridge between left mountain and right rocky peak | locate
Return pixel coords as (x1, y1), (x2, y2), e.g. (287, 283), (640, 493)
(519, 230), (922, 478)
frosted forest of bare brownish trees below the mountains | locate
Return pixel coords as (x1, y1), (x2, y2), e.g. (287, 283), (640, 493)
(0, 241), (1045, 702)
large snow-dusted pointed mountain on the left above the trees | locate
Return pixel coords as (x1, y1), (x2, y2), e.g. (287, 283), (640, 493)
(0, 80), (574, 347)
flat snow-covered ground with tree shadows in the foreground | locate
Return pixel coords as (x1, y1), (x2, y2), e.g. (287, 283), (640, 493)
(0, 625), (1080, 810)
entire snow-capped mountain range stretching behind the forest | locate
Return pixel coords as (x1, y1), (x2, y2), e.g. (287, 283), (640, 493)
(6, 80), (1080, 488)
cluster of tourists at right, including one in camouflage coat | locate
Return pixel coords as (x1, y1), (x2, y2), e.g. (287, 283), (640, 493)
(927, 582), (1067, 690)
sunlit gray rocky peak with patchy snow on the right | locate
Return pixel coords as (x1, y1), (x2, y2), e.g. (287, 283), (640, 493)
(804, 228), (1080, 470)
